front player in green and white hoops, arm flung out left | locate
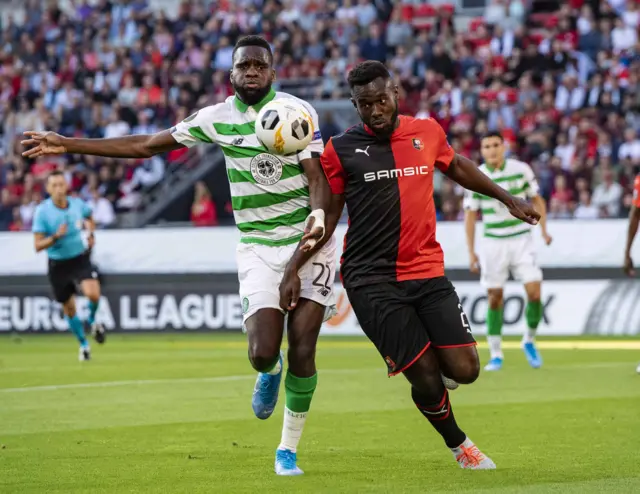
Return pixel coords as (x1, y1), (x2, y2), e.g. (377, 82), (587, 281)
(23, 36), (338, 475)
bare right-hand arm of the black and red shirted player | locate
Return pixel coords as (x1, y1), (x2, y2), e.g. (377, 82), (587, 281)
(444, 154), (540, 225)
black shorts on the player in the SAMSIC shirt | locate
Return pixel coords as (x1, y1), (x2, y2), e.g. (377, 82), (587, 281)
(347, 276), (476, 376)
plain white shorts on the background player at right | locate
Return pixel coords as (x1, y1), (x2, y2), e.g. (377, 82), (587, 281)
(480, 233), (542, 289)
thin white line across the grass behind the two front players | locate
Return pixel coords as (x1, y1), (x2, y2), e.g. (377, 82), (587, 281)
(0, 368), (381, 393)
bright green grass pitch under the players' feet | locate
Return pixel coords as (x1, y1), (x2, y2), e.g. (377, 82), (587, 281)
(0, 334), (640, 494)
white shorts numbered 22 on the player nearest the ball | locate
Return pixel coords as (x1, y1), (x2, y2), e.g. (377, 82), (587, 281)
(236, 237), (336, 322)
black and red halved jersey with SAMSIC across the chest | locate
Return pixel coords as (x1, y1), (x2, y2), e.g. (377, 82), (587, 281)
(320, 116), (455, 287)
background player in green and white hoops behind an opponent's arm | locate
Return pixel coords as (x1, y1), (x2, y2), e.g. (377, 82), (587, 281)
(464, 132), (551, 371)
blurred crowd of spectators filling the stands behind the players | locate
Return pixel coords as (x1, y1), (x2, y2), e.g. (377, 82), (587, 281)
(0, 0), (640, 230)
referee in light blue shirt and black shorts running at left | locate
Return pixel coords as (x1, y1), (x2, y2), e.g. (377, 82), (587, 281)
(32, 171), (105, 360)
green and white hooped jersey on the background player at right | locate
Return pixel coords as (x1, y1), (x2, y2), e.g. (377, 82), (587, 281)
(464, 158), (540, 238)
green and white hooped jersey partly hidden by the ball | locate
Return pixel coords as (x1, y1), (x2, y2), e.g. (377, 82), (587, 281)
(171, 90), (324, 247)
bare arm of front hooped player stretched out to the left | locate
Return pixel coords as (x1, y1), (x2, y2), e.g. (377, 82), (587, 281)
(22, 130), (184, 158)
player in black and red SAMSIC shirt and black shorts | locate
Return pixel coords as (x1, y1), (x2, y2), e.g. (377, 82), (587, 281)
(281, 61), (540, 469)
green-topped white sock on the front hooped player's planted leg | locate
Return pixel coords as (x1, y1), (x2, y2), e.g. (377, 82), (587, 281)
(278, 371), (318, 453)
